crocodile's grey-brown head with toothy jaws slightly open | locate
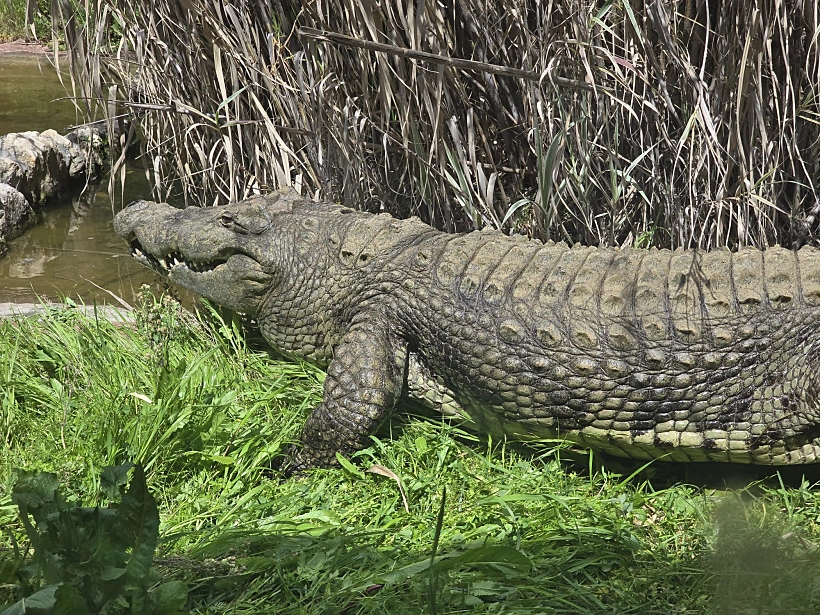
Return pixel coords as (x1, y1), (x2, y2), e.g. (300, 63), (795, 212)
(114, 198), (289, 315)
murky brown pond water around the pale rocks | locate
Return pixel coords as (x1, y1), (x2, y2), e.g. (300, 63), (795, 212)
(0, 55), (167, 305)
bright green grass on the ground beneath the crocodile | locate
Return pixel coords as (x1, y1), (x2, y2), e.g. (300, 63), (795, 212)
(0, 299), (820, 614)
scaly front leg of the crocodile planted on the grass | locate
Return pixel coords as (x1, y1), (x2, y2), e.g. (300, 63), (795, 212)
(287, 323), (407, 474)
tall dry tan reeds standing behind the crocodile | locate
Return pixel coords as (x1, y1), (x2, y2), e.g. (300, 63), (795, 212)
(52, 0), (820, 247)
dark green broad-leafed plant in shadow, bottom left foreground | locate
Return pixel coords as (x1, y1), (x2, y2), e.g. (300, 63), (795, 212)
(0, 463), (187, 615)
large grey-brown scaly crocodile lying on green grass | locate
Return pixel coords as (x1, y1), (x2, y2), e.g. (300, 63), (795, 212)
(115, 191), (820, 471)
